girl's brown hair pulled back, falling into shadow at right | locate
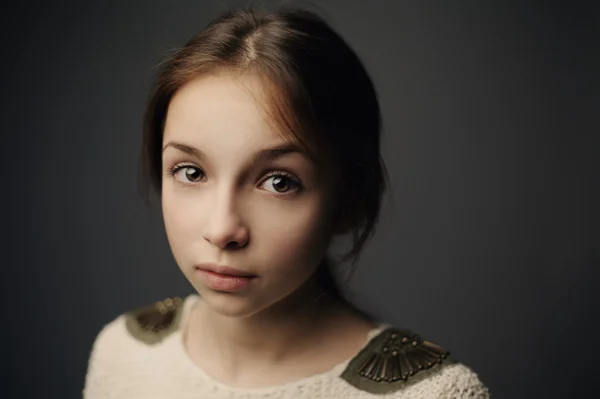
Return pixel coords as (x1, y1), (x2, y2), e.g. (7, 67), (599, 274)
(142, 9), (387, 302)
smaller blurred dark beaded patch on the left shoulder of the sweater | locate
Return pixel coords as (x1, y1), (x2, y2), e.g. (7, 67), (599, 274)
(125, 297), (183, 345)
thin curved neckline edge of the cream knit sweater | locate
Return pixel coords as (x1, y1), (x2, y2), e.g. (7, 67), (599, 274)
(176, 294), (389, 395)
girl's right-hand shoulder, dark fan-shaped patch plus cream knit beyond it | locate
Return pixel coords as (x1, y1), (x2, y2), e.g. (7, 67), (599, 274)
(341, 326), (489, 398)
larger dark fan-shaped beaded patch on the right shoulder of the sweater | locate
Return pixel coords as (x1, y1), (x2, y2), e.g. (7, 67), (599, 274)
(341, 327), (451, 394)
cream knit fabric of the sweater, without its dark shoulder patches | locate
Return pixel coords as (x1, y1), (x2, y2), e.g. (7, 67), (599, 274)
(83, 295), (489, 399)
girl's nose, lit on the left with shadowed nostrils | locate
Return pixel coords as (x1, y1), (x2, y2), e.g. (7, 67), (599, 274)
(203, 193), (249, 250)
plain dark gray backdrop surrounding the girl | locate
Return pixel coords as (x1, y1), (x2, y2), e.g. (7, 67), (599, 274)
(0, 0), (600, 398)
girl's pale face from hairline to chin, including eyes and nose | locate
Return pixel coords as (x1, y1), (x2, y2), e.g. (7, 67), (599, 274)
(162, 74), (333, 317)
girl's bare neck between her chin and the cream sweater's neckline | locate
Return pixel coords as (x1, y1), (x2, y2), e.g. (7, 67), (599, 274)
(188, 283), (356, 384)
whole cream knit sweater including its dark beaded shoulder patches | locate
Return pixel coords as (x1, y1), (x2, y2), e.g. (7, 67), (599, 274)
(83, 295), (489, 399)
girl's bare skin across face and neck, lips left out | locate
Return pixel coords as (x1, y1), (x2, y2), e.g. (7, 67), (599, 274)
(162, 73), (374, 387)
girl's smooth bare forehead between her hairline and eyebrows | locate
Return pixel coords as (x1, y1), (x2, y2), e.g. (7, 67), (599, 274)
(163, 74), (289, 144)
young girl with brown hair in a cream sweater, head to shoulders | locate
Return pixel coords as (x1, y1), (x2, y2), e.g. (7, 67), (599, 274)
(84, 6), (489, 399)
